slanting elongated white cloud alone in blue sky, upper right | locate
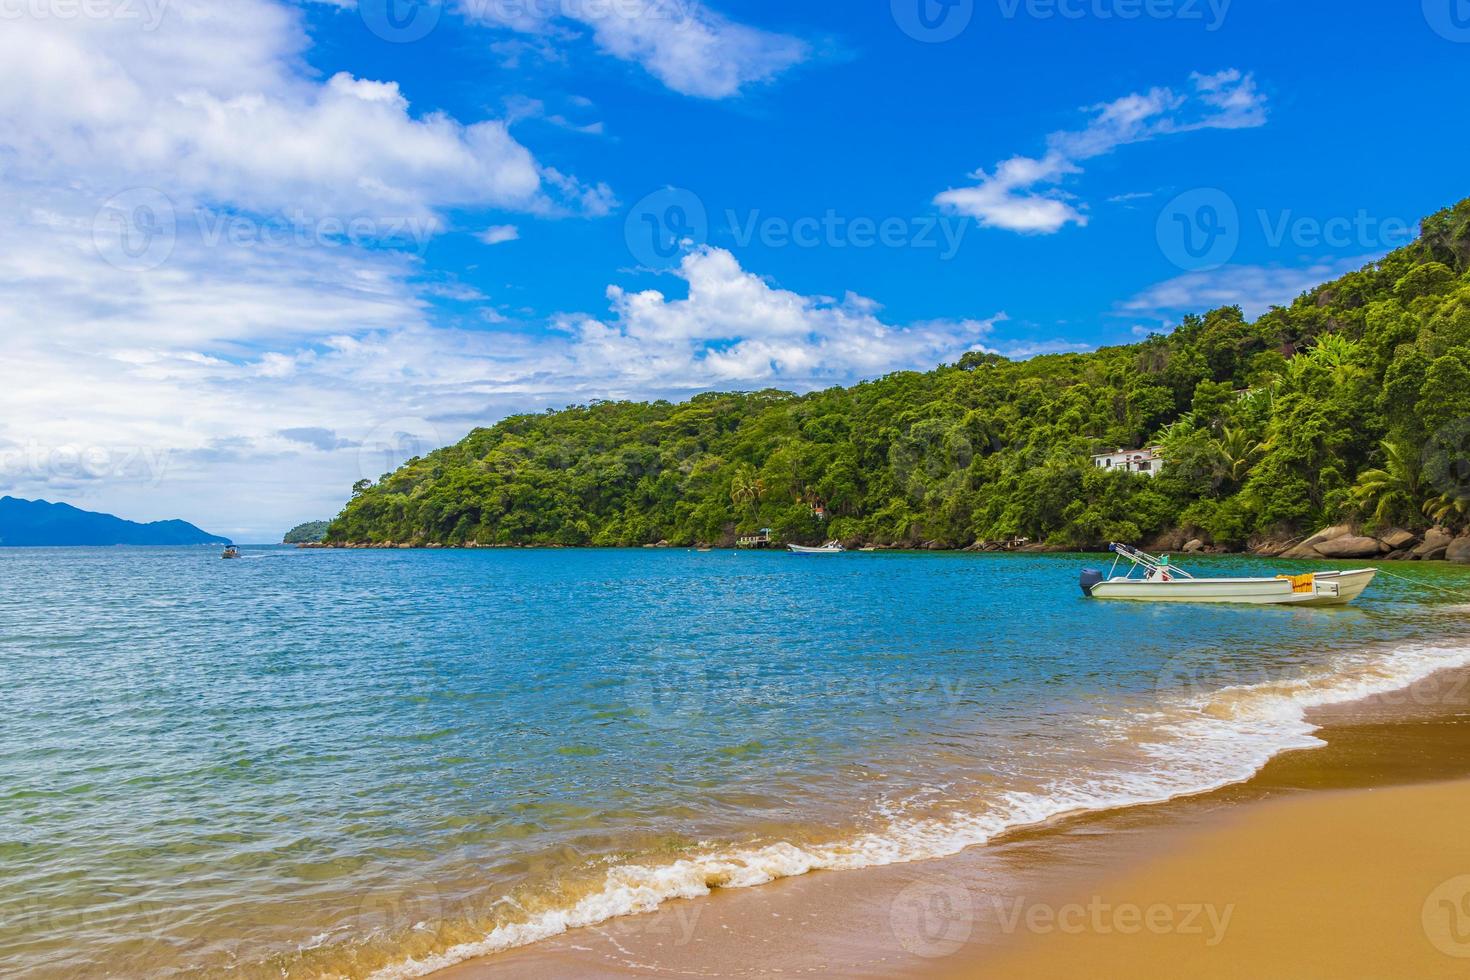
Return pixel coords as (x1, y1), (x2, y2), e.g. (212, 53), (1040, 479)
(935, 69), (1266, 235)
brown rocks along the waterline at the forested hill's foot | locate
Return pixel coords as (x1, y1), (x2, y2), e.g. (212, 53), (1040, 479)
(297, 525), (1470, 564)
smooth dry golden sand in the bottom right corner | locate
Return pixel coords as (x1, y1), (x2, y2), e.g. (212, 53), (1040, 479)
(976, 780), (1470, 977)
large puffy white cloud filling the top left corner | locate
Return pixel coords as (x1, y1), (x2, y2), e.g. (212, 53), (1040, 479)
(0, 0), (602, 222)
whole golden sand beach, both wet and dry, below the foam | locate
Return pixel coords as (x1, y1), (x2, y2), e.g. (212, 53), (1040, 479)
(435, 671), (1470, 980)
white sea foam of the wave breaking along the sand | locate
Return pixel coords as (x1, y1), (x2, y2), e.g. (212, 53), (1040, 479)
(372, 645), (1470, 980)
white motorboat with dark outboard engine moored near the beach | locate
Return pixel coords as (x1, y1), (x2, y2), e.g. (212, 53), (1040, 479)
(1082, 544), (1377, 605)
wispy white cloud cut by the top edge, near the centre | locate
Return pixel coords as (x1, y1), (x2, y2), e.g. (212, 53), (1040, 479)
(460, 0), (810, 98)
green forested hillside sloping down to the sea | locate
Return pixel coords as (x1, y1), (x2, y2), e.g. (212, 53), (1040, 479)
(328, 201), (1470, 547)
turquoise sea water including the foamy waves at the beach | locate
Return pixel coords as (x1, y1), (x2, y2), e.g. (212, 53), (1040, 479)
(0, 548), (1470, 976)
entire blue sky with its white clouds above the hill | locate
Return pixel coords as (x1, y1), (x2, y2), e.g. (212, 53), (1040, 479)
(0, 0), (1470, 541)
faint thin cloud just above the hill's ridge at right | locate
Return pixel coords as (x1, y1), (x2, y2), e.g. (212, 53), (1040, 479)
(1114, 256), (1379, 323)
